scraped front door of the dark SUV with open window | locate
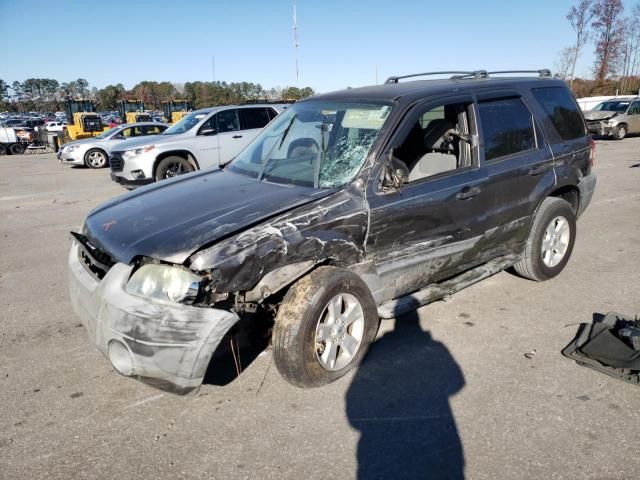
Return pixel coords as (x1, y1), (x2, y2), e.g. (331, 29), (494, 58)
(366, 96), (487, 300)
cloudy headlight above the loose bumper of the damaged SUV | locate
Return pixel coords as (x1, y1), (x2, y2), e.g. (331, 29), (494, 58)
(126, 264), (202, 304)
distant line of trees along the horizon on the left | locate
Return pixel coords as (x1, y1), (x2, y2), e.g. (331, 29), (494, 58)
(0, 78), (314, 112)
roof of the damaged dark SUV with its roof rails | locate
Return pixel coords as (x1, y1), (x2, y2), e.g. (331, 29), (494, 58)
(310, 76), (565, 105)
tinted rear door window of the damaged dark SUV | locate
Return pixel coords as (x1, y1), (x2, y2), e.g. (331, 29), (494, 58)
(478, 98), (536, 162)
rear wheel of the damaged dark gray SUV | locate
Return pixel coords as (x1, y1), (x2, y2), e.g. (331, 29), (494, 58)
(514, 197), (576, 282)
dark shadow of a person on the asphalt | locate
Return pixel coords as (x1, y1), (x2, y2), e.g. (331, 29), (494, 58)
(346, 311), (464, 480)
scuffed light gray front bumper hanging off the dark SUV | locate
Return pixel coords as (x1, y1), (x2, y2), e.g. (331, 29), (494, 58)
(69, 241), (238, 395)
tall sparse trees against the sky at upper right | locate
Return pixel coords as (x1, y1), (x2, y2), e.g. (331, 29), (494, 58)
(556, 0), (640, 97)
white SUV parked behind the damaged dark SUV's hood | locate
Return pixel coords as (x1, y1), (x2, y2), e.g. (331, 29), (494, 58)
(110, 104), (288, 188)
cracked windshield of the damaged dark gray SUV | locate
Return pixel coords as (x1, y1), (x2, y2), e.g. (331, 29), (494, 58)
(229, 101), (391, 188)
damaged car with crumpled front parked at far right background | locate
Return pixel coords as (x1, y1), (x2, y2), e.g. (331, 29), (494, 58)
(584, 97), (640, 140)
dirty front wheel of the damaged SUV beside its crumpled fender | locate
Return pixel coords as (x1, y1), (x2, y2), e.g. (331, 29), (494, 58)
(272, 267), (380, 388)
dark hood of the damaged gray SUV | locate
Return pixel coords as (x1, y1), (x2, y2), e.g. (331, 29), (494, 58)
(83, 170), (331, 264)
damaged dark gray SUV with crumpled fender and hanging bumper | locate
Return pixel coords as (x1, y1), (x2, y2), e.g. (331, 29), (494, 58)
(68, 70), (596, 394)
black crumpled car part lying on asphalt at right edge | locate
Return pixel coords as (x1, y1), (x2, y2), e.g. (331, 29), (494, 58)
(562, 312), (640, 386)
